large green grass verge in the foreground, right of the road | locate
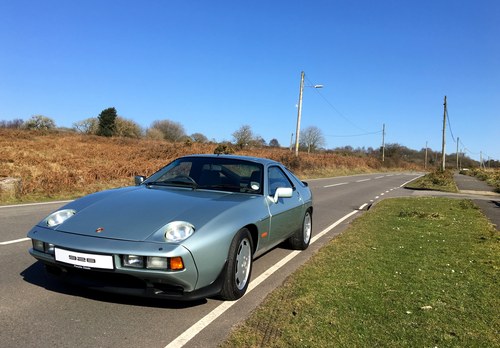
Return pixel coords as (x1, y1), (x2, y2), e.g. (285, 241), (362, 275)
(222, 198), (500, 347)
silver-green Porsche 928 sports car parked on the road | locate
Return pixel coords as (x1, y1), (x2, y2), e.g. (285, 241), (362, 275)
(28, 155), (313, 300)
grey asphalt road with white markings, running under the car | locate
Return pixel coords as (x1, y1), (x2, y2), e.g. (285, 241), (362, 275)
(0, 173), (419, 348)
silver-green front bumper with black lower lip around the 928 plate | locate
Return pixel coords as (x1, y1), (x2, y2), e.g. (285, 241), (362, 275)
(28, 226), (221, 300)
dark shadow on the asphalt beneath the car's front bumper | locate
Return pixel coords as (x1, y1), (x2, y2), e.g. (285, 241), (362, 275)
(20, 261), (208, 309)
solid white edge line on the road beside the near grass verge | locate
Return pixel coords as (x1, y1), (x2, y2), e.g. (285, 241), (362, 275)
(165, 210), (358, 348)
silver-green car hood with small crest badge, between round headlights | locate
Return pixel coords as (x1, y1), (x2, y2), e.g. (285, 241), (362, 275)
(51, 186), (251, 241)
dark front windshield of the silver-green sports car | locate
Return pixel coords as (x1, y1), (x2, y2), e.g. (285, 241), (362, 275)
(144, 157), (263, 194)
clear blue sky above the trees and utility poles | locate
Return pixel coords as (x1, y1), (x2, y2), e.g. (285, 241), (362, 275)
(0, 0), (500, 159)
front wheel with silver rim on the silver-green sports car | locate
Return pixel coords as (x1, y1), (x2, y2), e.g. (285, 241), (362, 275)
(220, 228), (253, 301)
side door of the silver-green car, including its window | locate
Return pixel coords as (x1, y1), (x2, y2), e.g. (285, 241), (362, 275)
(267, 166), (303, 244)
